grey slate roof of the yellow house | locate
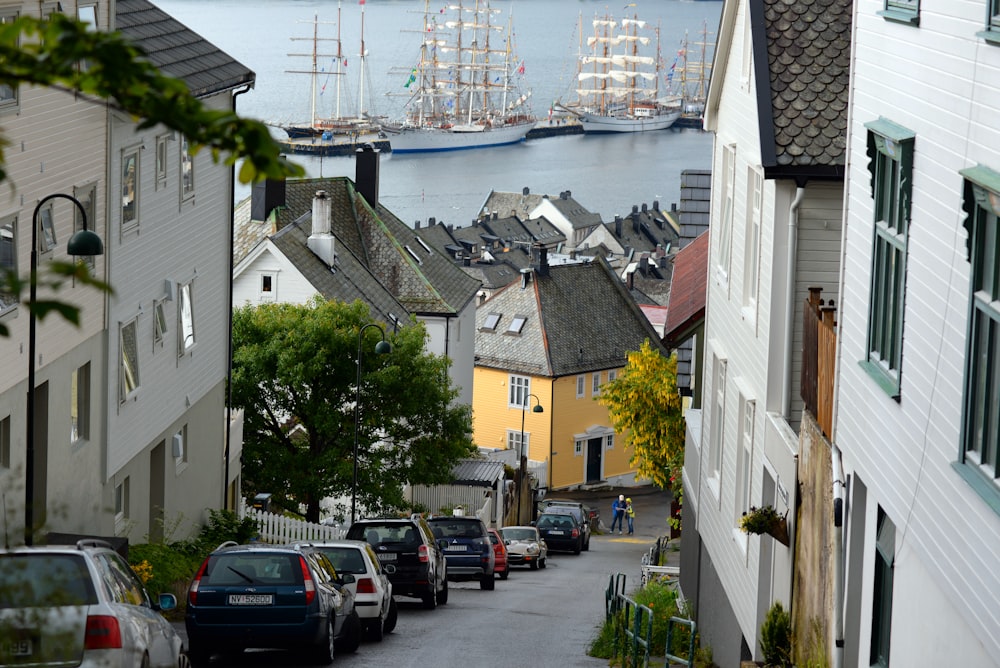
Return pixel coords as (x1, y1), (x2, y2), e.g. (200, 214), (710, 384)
(476, 258), (663, 378)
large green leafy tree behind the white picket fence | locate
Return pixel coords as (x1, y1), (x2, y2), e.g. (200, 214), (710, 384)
(232, 298), (475, 522)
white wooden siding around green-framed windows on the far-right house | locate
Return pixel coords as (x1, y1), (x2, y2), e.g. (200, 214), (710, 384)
(835, 0), (1000, 665)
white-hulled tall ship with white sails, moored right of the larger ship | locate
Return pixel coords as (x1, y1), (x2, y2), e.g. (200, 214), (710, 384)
(565, 10), (681, 133)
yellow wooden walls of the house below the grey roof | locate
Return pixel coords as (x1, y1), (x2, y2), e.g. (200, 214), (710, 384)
(472, 367), (633, 489)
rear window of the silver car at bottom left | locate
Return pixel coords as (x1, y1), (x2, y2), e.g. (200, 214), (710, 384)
(0, 554), (97, 608)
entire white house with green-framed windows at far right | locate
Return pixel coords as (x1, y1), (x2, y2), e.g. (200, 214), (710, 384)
(834, 0), (1000, 667)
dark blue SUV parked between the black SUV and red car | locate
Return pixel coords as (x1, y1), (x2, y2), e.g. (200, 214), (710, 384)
(427, 515), (496, 591)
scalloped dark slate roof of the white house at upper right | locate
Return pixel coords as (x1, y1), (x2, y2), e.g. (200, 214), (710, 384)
(750, 0), (852, 178)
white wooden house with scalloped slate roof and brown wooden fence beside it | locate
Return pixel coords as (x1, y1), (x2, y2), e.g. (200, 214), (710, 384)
(684, 0), (851, 666)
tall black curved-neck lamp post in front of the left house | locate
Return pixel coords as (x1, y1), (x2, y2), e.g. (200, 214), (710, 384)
(24, 193), (104, 545)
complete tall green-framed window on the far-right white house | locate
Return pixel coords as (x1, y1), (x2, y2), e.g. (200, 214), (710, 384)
(862, 119), (914, 398)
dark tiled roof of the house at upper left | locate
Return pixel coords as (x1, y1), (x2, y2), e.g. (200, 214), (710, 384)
(115, 0), (256, 97)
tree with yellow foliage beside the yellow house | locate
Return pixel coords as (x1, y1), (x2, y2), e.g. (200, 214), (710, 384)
(598, 340), (685, 499)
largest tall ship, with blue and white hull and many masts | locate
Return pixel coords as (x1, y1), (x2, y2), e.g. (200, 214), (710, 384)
(381, 0), (537, 153)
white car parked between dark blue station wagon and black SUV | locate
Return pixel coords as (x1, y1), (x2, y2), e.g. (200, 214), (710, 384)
(313, 540), (396, 641)
